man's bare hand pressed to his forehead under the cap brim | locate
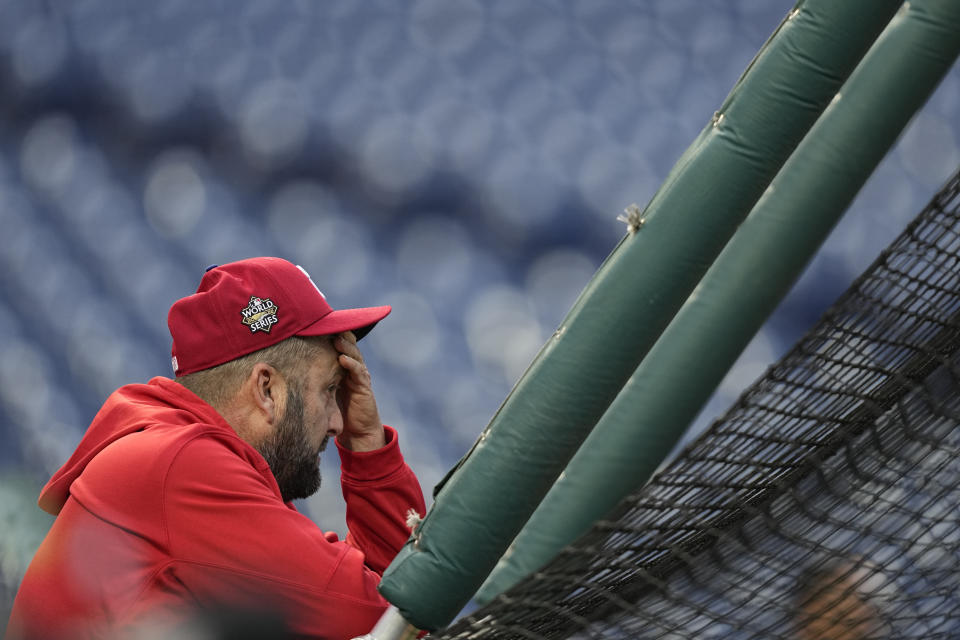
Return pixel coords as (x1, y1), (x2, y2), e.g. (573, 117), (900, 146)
(333, 331), (385, 451)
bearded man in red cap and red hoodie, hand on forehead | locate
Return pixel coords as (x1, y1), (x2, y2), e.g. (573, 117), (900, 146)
(8, 258), (425, 639)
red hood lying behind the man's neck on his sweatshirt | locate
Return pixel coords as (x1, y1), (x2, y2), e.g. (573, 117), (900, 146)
(38, 377), (234, 515)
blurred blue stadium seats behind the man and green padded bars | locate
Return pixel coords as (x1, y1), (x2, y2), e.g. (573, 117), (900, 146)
(0, 0), (960, 632)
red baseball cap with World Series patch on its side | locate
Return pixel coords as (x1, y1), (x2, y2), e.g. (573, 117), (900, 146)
(167, 258), (390, 376)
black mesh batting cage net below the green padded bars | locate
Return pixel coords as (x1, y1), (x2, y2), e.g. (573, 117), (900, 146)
(438, 168), (960, 639)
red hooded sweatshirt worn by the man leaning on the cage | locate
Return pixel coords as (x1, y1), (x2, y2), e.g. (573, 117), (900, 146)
(8, 378), (425, 639)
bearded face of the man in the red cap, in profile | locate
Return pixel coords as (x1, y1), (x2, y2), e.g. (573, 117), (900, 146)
(259, 346), (343, 502)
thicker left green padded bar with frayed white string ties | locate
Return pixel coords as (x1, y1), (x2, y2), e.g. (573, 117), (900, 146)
(380, 0), (900, 629)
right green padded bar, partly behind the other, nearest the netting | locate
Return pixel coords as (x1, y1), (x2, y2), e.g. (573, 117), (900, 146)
(475, 0), (960, 603)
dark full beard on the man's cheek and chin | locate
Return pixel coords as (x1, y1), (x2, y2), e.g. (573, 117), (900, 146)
(257, 384), (327, 502)
